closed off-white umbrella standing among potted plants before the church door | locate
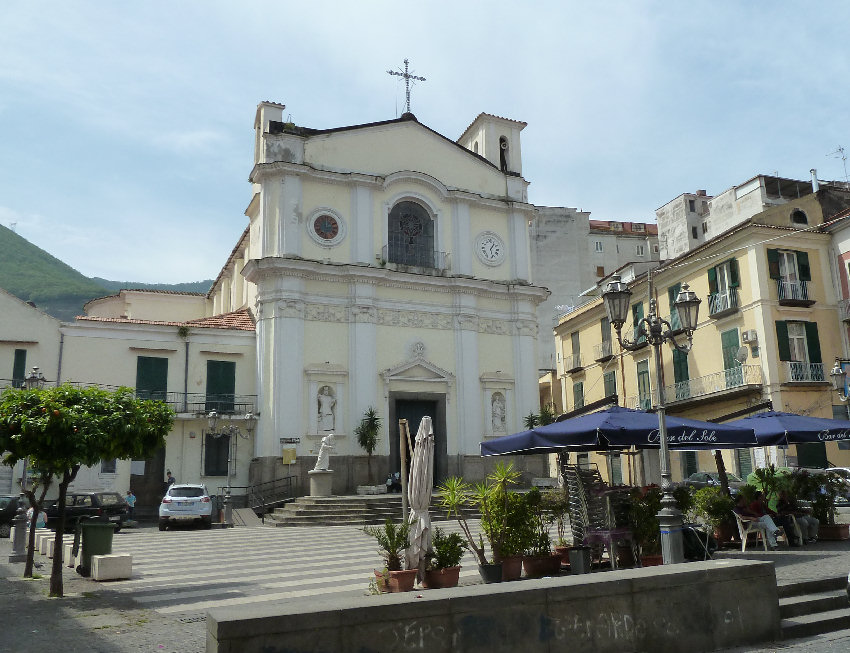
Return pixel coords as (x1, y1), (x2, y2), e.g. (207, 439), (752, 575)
(407, 416), (434, 580)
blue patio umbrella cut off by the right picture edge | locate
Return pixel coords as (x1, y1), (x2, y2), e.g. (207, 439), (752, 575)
(725, 410), (850, 446)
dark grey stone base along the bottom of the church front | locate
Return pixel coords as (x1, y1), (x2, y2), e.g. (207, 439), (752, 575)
(249, 455), (549, 496)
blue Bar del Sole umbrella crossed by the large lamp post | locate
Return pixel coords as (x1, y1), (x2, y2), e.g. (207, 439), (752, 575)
(480, 406), (758, 456)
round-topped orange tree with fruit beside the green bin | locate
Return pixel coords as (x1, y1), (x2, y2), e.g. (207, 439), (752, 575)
(0, 383), (174, 596)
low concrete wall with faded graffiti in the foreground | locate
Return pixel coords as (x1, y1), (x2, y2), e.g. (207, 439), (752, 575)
(207, 560), (779, 653)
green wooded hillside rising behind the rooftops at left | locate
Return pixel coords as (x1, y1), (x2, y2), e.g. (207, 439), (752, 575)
(0, 225), (212, 320)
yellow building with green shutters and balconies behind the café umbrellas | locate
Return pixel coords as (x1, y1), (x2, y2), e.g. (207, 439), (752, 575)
(555, 183), (850, 482)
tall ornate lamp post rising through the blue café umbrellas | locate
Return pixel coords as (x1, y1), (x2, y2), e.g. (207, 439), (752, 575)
(602, 270), (701, 565)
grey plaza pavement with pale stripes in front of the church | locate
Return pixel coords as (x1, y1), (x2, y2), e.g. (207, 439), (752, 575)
(0, 522), (850, 653)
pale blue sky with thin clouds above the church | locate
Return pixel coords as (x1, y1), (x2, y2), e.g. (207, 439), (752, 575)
(0, 0), (850, 283)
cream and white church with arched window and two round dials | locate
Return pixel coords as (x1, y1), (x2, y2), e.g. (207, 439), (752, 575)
(209, 102), (548, 491)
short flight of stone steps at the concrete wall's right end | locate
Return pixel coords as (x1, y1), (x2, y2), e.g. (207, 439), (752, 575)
(778, 576), (850, 639)
